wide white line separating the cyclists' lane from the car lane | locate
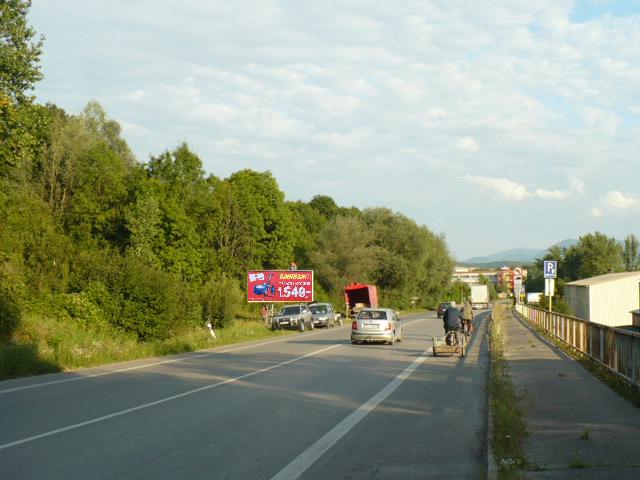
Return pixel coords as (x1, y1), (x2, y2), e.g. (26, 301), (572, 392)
(271, 349), (431, 480)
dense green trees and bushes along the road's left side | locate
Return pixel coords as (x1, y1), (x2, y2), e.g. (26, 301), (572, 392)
(0, 0), (453, 377)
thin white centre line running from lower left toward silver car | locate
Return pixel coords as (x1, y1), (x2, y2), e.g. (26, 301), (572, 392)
(0, 342), (346, 450)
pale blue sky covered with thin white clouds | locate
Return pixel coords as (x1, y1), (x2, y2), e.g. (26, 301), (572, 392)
(29, 0), (640, 260)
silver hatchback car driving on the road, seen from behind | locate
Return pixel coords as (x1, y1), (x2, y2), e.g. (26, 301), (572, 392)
(351, 308), (402, 345)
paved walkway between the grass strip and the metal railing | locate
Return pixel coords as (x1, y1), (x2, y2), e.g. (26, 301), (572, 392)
(504, 314), (640, 480)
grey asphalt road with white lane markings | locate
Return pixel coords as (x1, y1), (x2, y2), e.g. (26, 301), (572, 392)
(0, 312), (488, 480)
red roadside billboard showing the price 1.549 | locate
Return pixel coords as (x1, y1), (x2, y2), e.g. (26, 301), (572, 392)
(247, 270), (313, 303)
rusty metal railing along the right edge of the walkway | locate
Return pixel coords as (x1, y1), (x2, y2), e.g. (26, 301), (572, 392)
(516, 303), (640, 387)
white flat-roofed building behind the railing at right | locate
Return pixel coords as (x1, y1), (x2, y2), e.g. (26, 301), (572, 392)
(564, 272), (640, 327)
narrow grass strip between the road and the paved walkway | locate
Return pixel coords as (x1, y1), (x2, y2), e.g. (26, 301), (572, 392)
(488, 303), (527, 480)
